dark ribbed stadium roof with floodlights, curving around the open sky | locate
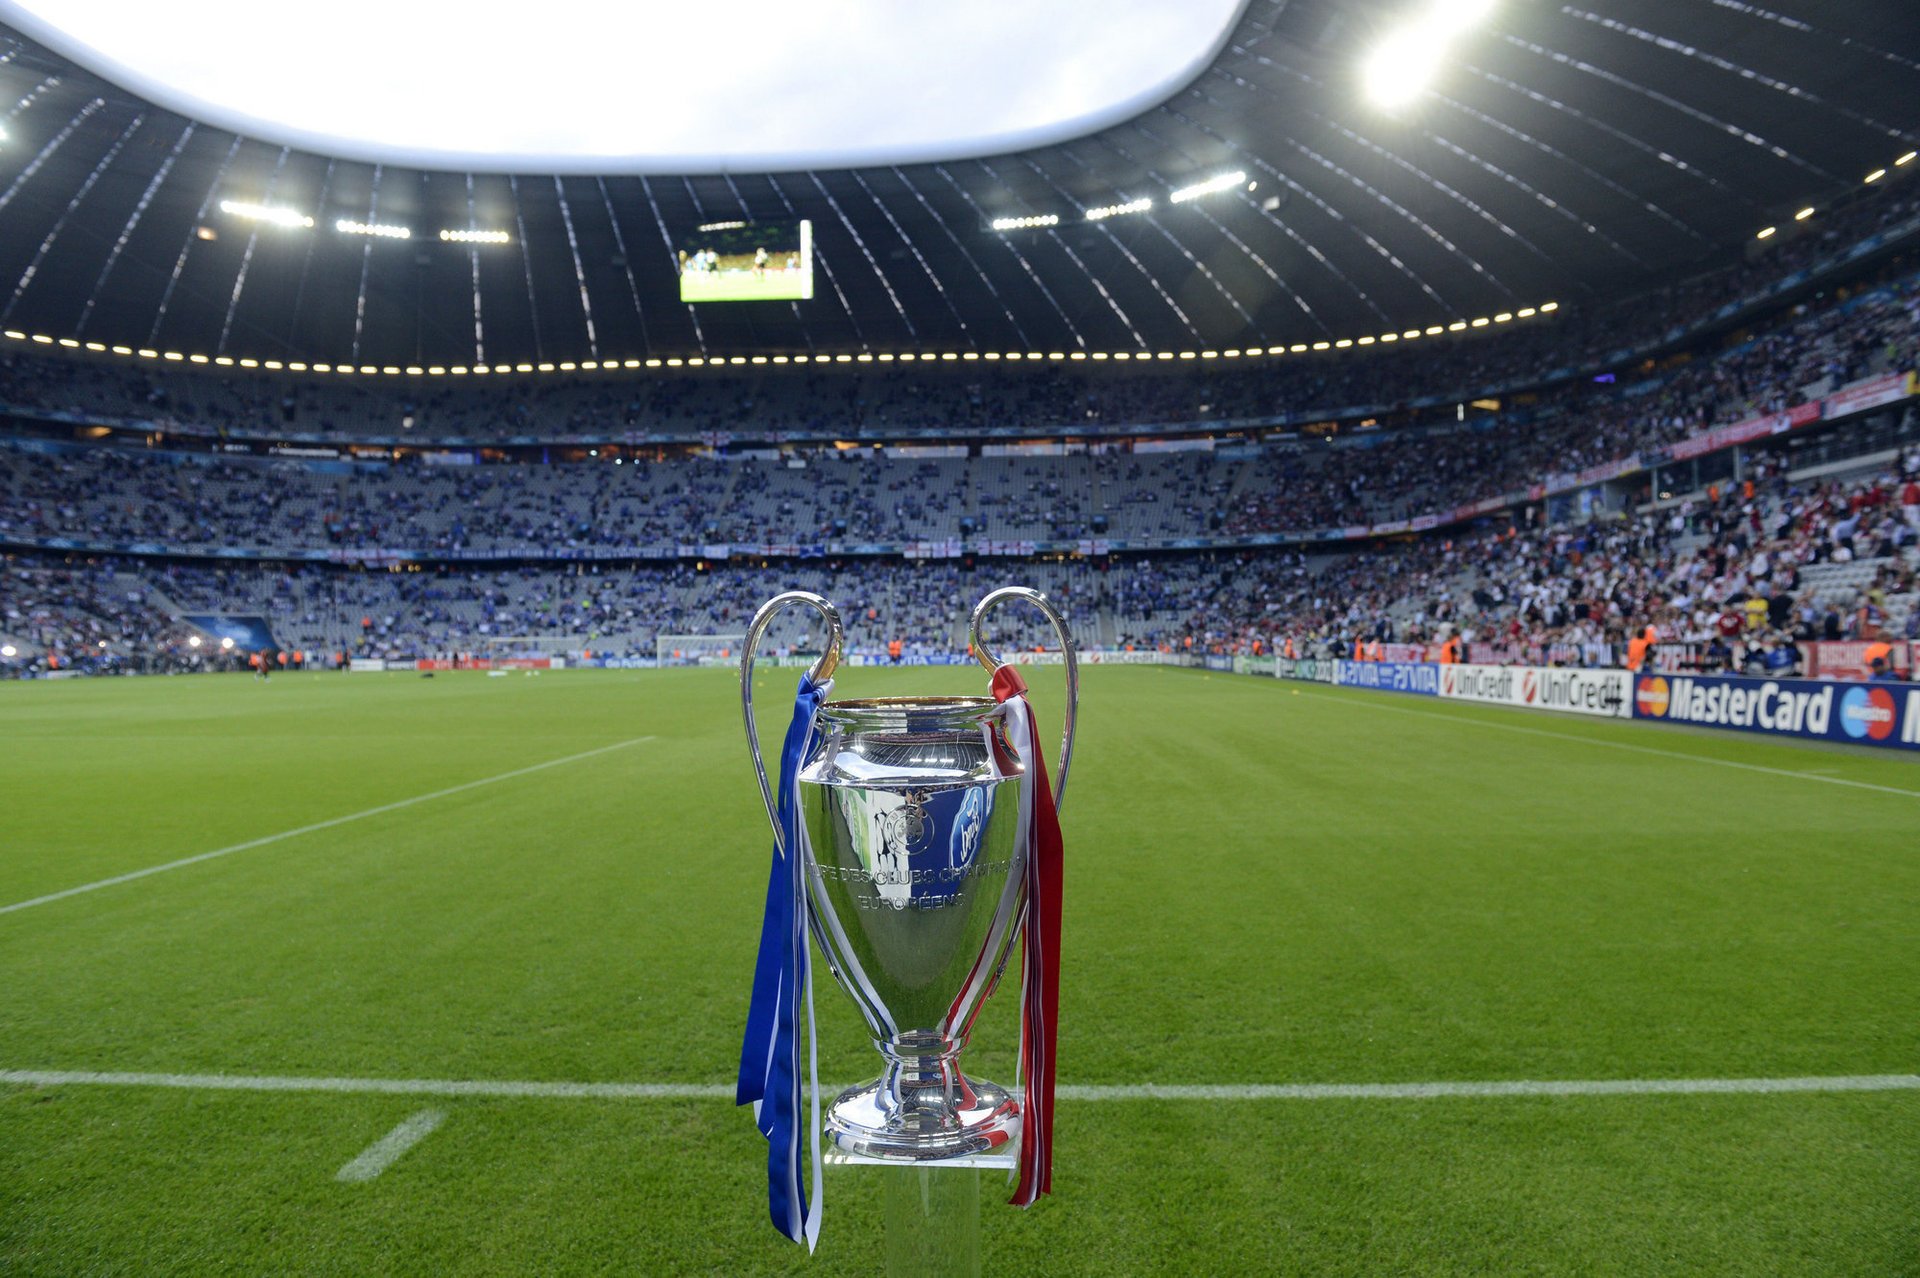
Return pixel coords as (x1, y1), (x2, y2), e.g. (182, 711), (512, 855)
(0, 0), (1920, 365)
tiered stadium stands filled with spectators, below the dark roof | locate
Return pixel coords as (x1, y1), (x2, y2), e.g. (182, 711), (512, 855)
(0, 200), (1920, 672)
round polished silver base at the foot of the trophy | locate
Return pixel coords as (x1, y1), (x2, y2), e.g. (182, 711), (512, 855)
(826, 1075), (1020, 1167)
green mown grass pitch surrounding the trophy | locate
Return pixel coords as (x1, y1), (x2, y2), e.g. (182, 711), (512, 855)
(0, 668), (1920, 1276)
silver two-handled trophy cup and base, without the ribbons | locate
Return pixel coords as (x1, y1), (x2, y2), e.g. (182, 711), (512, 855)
(741, 587), (1079, 1163)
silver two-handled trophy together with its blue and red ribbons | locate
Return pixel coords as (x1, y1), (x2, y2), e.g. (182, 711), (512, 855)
(737, 587), (1079, 1243)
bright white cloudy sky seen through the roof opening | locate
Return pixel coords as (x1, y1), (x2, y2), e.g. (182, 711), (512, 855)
(0, 0), (1246, 175)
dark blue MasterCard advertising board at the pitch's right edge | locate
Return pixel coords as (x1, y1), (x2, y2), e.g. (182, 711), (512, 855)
(1634, 675), (1920, 750)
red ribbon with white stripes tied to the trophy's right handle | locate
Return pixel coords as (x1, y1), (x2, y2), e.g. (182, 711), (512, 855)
(993, 666), (1064, 1207)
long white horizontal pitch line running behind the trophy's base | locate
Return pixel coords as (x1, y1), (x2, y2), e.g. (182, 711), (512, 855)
(0, 1069), (1920, 1101)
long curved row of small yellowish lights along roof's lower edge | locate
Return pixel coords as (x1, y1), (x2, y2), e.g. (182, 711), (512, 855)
(0, 301), (1559, 378)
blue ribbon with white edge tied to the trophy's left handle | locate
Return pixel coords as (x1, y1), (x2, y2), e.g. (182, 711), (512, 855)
(733, 674), (833, 1247)
